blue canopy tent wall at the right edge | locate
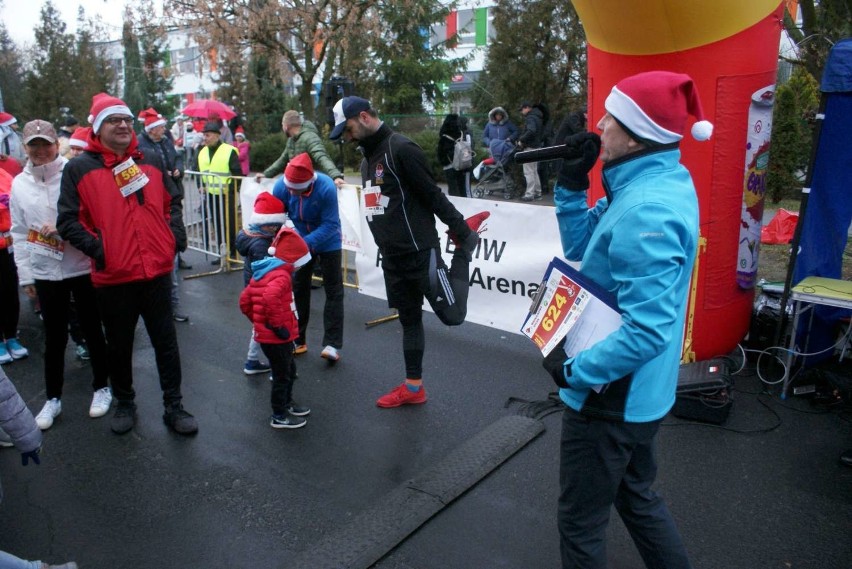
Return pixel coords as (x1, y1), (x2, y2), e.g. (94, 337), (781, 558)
(781, 38), (852, 365)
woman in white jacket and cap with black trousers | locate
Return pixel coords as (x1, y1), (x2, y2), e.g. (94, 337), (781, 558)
(10, 120), (111, 430)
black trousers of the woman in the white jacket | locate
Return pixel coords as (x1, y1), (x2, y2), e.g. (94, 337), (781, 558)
(35, 275), (109, 399)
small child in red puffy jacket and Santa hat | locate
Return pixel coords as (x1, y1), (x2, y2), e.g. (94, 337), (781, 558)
(240, 227), (311, 429)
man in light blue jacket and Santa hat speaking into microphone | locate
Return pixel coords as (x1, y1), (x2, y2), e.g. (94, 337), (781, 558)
(544, 71), (712, 568)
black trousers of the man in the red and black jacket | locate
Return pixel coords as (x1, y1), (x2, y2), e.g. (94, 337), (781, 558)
(95, 274), (182, 409)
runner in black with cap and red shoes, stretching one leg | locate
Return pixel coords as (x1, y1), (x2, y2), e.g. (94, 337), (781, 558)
(331, 97), (489, 407)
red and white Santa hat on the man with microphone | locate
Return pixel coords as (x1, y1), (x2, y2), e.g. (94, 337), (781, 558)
(604, 71), (713, 144)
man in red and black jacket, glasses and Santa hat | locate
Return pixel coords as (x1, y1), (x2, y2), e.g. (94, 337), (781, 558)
(56, 93), (198, 435)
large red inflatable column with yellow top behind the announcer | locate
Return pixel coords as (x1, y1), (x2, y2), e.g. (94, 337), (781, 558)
(574, 0), (783, 360)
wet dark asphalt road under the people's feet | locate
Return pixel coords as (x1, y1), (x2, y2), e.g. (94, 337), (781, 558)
(0, 254), (852, 569)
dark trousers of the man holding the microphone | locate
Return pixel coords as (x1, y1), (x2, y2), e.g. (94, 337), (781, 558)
(557, 408), (692, 569)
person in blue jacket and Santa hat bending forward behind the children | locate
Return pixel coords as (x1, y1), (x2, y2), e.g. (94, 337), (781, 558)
(272, 152), (343, 364)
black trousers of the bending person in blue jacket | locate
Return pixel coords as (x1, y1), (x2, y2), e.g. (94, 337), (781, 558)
(293, 250), (343, 349)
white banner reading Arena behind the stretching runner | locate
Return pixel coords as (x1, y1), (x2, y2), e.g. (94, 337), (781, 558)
(356, 197), (562, 334)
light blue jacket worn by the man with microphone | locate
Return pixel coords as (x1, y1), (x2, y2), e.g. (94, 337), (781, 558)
(554, 145), (699, 423)
